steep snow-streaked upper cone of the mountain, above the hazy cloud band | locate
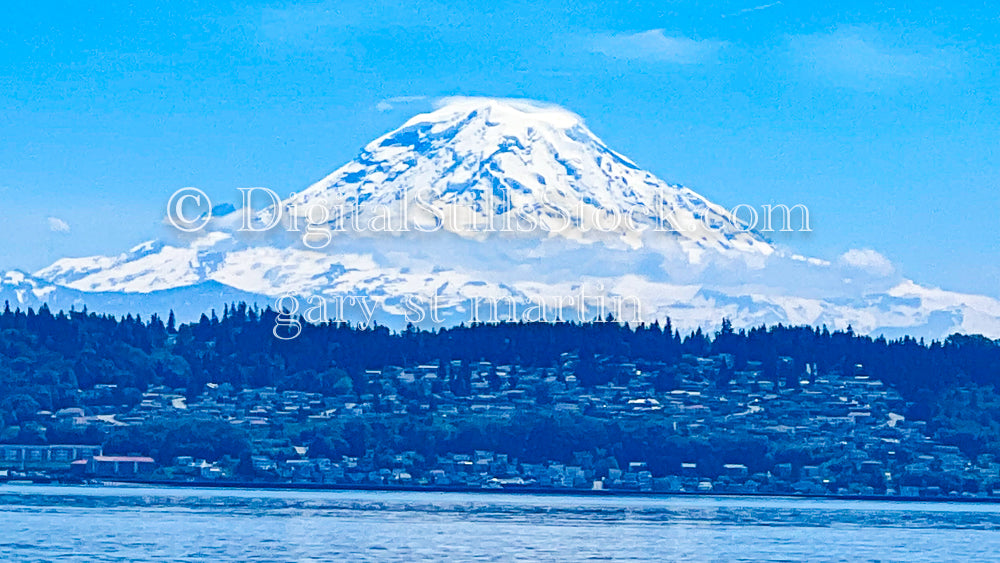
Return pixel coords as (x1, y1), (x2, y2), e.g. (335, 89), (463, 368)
(262, 98), (773, 260)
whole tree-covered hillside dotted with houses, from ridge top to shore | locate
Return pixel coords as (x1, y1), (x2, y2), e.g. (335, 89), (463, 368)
(0, 307), (1000, 498)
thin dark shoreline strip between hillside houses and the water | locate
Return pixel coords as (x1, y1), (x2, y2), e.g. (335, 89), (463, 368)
(9, 479), (1000, 504)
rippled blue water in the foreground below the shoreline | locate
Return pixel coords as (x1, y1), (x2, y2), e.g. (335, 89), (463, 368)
(0, 485), (1000, 561)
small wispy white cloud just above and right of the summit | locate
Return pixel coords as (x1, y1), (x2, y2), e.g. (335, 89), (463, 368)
(590, 29), (725, 64)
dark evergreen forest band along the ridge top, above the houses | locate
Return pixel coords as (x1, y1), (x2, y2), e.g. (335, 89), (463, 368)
(0, 304), (1000, 404)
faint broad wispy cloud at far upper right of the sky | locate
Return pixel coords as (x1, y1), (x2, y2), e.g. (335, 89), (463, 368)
(790, 27), (962, 89)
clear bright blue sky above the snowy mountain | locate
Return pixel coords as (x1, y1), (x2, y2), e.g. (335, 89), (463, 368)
(0, 0), (1000, 296)
